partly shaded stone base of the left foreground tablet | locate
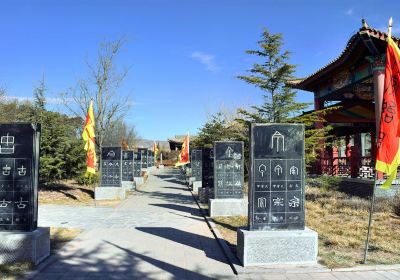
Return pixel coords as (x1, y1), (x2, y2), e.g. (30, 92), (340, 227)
(0, 227), (50, 265)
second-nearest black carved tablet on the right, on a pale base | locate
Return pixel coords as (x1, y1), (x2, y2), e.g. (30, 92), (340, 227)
(214, 141), (244, 199)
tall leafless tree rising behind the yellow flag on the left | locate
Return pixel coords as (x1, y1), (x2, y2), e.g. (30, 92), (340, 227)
(61, 38), (130, 149)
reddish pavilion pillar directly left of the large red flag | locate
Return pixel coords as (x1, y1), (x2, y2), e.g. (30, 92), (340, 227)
(367, 54), (386, 179)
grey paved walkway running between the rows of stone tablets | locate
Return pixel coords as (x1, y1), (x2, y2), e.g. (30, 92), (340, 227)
(28, 169), (400, 280)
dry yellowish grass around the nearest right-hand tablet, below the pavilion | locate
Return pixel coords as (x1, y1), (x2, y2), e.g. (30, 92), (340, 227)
(213, 186), (400, 268)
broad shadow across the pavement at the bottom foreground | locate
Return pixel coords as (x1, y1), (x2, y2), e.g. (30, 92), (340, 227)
(26, 240), (230, 280)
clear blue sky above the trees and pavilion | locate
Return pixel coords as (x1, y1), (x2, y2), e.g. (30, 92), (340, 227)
(0, 0), (400, 140)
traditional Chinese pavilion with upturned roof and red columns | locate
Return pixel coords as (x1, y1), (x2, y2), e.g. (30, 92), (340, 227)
(288, 20), (399, 178)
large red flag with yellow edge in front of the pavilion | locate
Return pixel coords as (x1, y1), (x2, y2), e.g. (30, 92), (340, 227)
(375, 35), (400, 188)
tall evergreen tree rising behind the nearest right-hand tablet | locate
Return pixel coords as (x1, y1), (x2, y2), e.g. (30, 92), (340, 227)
(238, 29), (336, 164)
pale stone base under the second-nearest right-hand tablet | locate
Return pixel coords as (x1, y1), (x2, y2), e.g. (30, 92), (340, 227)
(208, 198), (248, 217)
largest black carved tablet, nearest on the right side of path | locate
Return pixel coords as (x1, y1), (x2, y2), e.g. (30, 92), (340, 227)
(249, 124), (305, 230)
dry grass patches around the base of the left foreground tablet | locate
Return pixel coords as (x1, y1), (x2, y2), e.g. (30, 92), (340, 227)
(0, 228), (81, 280)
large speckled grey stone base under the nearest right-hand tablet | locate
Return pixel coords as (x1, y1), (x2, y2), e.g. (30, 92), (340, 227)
(237, 228), (318, 266)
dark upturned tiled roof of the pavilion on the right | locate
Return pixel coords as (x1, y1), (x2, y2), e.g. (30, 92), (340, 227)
(287, 20), (400, 91)
